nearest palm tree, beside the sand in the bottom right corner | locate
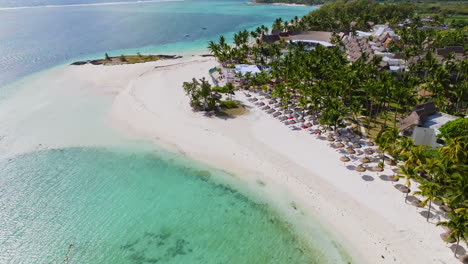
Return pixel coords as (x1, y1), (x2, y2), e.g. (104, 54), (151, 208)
(437, 208), (468, 257)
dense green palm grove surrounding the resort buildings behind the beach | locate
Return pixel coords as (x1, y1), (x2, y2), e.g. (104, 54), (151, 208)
(184, 0), (468, 256)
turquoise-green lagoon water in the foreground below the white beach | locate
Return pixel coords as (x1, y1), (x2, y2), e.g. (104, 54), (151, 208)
(0, 148), (326, 263)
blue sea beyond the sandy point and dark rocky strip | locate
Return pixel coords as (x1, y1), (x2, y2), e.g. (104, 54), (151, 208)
(0, 0), (313, 88)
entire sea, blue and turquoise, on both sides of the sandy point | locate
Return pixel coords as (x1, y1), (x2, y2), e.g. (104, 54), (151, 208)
(0, 0), (348, 264)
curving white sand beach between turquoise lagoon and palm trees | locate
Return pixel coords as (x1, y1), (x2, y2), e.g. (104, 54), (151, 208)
(0, 56), (464, 264)
